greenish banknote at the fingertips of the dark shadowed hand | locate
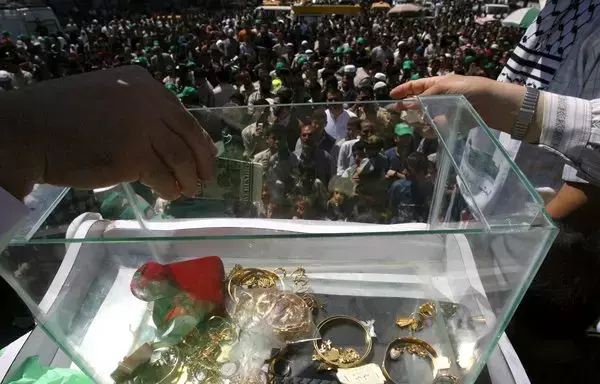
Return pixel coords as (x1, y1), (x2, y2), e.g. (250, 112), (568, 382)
(196, 157), (263, 202)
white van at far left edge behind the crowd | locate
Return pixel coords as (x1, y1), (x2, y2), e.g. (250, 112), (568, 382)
(0, 7), (62, 38)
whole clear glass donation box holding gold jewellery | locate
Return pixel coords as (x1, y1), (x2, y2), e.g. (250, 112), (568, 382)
(0, 96), (556, 384)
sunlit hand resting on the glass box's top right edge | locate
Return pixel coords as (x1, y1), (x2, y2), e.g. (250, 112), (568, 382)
(390, 75), (528, 137)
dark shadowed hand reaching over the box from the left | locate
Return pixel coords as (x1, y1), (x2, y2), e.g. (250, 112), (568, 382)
(0, 66), (217, 200)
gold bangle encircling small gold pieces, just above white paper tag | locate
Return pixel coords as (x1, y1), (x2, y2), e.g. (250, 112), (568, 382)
(313, 316), (373, 370)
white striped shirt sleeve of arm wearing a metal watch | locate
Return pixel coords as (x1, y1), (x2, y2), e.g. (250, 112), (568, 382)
(540, 92), (600, 186)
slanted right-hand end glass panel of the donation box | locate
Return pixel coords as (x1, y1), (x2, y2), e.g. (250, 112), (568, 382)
(421, 96), (544, 227)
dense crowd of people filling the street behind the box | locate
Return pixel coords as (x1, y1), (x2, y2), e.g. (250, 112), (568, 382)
(0, 2), (522, 223)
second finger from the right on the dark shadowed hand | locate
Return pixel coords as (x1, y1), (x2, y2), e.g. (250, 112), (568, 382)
(152, 129), (198, 197)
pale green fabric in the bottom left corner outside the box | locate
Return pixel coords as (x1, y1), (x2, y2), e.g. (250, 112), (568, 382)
(6, 356), (94, 384)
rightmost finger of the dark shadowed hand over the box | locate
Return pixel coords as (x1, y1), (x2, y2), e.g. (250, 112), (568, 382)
(164, 108), (217, 180)
